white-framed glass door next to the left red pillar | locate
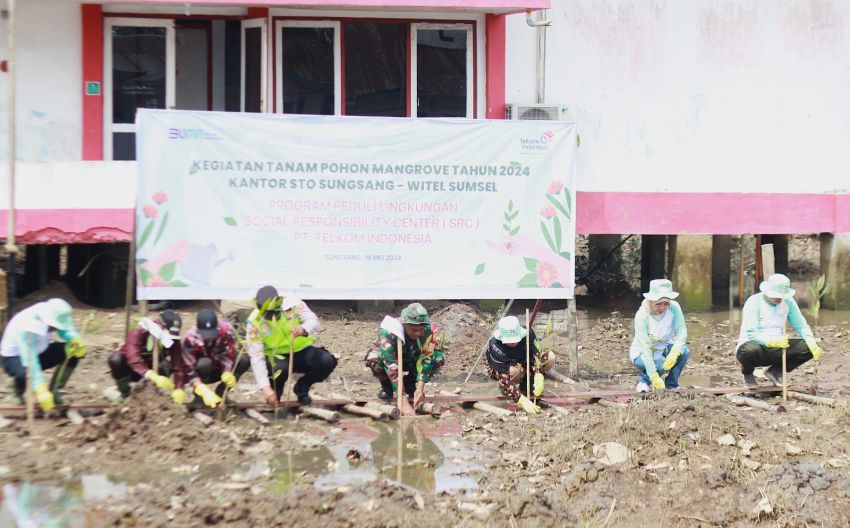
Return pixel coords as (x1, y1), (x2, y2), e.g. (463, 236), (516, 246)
(103, 18), (175, 160)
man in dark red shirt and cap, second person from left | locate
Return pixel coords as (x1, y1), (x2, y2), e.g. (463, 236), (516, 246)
(109, 310), (183, 398)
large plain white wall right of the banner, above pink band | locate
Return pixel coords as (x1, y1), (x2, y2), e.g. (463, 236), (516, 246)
(506, 0), (850, 192)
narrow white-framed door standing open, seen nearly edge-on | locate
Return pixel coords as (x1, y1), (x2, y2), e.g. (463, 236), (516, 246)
(240, 18), (266, 112)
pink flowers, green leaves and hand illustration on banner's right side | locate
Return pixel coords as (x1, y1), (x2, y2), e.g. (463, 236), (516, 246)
(475, 180), (572, 288)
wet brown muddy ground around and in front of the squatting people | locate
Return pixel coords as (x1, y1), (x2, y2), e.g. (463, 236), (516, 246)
(0, 288), (850, 528)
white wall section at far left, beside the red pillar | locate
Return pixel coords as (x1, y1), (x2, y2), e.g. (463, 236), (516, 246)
(0, 1), (82, 161)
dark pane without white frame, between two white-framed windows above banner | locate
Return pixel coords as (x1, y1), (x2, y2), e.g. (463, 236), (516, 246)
(343, 22), (408, 117)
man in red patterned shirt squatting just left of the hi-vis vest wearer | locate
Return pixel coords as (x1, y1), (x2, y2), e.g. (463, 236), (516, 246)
(172, 308), (251, 407)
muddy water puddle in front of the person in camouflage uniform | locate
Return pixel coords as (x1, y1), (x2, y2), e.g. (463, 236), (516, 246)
(268, 420), (483, 494)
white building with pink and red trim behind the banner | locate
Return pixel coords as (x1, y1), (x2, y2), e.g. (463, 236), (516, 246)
(0, 0), (850, 305)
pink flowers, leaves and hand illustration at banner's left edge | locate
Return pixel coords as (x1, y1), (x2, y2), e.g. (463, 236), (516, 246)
(136, 191), (188, 287)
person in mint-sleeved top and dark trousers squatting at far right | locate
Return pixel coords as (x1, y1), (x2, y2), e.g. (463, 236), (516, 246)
(735, 273), (823, 387)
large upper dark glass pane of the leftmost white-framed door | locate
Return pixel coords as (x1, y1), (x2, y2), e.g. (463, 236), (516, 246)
(112, 26), (165, 125)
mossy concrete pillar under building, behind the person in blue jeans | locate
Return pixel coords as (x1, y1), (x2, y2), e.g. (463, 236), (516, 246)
(672, 235), (712, 312)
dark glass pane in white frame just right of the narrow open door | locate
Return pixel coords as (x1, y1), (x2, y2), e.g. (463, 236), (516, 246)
(280, 27), (334, 115)
